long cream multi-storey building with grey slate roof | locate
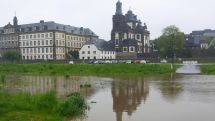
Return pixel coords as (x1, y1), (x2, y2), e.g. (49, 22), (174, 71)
(0, 17), (98, 60)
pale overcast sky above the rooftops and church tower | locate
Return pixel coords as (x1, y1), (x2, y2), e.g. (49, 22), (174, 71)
(0, 0), (215, 40)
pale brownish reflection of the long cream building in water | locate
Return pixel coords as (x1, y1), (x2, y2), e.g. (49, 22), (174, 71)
(3, 76), (107, 97)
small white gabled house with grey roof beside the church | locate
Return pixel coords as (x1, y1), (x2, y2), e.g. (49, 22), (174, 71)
(79, 39), (116, 60)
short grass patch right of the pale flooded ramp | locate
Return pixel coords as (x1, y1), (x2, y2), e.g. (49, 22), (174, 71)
(200, 64), (215, 75)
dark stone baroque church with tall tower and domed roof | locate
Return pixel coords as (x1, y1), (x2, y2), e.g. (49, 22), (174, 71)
(111, 1), (150, 53)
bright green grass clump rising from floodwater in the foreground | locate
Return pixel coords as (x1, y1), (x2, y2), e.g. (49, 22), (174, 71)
(0, 91), (85, 121)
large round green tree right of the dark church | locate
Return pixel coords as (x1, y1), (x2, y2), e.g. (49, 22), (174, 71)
(155, 25), (185, 58)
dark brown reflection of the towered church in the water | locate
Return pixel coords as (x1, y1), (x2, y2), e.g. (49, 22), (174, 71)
(112, 80), (149, 121)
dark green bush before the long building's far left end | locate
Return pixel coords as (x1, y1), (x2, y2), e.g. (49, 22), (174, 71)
(2, 51), (21, 62)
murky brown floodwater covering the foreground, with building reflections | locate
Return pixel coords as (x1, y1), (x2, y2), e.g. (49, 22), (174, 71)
(1, 75), (215, 121)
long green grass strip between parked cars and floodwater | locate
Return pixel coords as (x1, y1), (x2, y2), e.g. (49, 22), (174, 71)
(0, 64), (175, 75)
